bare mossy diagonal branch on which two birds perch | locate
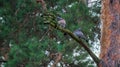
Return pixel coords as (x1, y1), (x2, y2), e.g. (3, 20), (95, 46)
(50, 23), (100, 65)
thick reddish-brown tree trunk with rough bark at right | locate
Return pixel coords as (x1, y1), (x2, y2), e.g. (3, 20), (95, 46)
(99, 0), (120, 67)
